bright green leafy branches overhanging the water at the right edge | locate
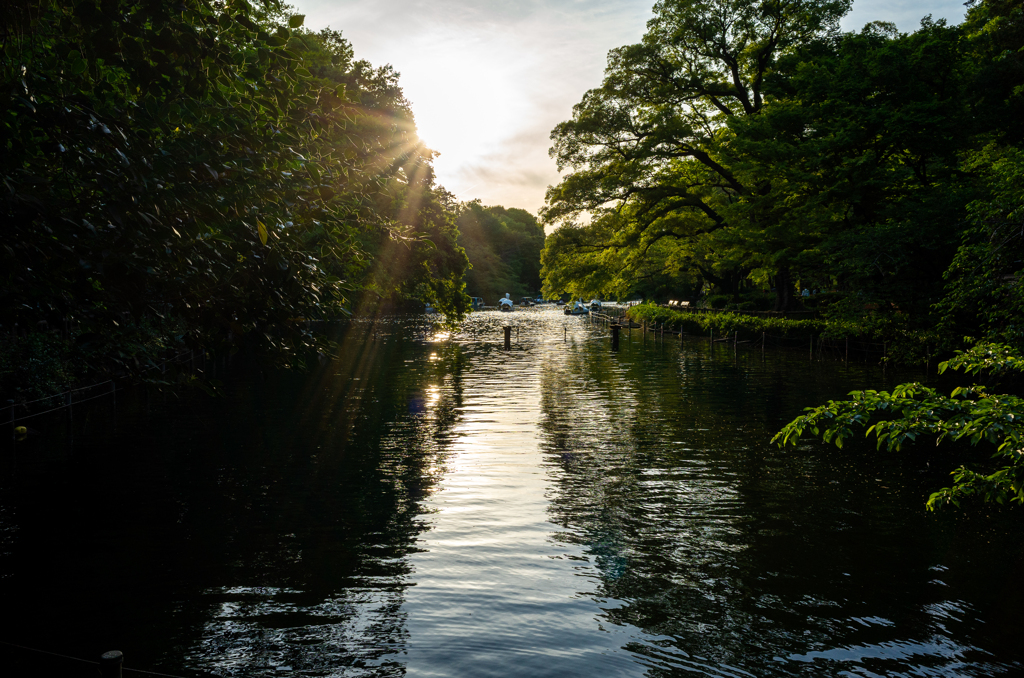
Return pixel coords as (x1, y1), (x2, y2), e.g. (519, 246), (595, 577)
(772, 343), (1024, 510)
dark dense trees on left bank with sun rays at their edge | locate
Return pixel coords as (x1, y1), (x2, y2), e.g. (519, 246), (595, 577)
(0, 0), (468, 398)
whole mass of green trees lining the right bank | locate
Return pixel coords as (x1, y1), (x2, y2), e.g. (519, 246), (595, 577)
(543, 0), (1024, 347)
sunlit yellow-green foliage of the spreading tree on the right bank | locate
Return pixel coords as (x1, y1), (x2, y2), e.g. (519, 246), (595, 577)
(542, 0), (849, 309)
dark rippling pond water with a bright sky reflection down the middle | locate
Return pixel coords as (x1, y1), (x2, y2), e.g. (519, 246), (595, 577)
(0, 308), (1024, 678)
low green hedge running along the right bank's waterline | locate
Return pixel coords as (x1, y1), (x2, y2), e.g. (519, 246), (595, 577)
(626, 303), (941, 365)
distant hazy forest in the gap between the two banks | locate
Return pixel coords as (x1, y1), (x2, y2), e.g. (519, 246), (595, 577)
(457, 201), (544, 304)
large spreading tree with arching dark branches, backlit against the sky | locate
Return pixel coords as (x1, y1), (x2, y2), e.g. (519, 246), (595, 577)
(542, 0), (849, 308)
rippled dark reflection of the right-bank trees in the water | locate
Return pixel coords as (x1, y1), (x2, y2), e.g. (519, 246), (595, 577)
(540, 344), (1019, 675)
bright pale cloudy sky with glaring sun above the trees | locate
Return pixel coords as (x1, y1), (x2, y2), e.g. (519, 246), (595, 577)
(290, 0), (964, 212)
